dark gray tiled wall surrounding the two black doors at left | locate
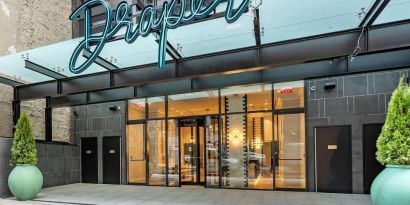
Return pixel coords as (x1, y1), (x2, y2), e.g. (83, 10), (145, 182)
(71, 101), (127, 184)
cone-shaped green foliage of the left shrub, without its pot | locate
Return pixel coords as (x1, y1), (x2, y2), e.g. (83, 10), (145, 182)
(10, 112), (38, 166)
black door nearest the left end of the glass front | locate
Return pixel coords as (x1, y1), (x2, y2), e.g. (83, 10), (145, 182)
(103, 136), (121, 184)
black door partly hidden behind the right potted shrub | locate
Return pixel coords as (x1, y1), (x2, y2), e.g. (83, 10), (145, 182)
(363, 124), (384, 194)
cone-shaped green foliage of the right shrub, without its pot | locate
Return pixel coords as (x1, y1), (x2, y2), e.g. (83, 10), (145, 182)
(376, 78), (410, 165)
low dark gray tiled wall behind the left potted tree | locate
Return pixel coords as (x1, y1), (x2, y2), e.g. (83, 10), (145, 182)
(0, 138), (80, 197)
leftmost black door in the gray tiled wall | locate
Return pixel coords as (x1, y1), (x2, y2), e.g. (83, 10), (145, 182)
(81, 137), (98, 183)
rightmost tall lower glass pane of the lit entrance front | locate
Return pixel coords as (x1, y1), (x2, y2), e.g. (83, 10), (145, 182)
(275, 113), (306, 189)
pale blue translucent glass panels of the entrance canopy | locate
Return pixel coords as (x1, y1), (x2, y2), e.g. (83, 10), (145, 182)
(0, 0), (410, 83)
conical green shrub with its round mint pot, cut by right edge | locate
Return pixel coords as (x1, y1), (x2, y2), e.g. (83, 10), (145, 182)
(371, 78), (410, 205)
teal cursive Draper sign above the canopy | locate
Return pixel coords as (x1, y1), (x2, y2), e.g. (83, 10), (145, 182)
(69, 0), (250, 74)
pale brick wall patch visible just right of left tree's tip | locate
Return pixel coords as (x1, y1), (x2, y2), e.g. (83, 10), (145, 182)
(20, 99), (46, 139)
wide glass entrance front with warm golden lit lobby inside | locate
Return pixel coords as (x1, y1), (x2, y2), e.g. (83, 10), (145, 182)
(127, 81), (306, 190)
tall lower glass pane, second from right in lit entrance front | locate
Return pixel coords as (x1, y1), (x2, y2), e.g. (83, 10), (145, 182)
(246, 113), (274, 189)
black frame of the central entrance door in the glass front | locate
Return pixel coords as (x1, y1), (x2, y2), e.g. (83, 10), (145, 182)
(178, 116), (206, 187)
